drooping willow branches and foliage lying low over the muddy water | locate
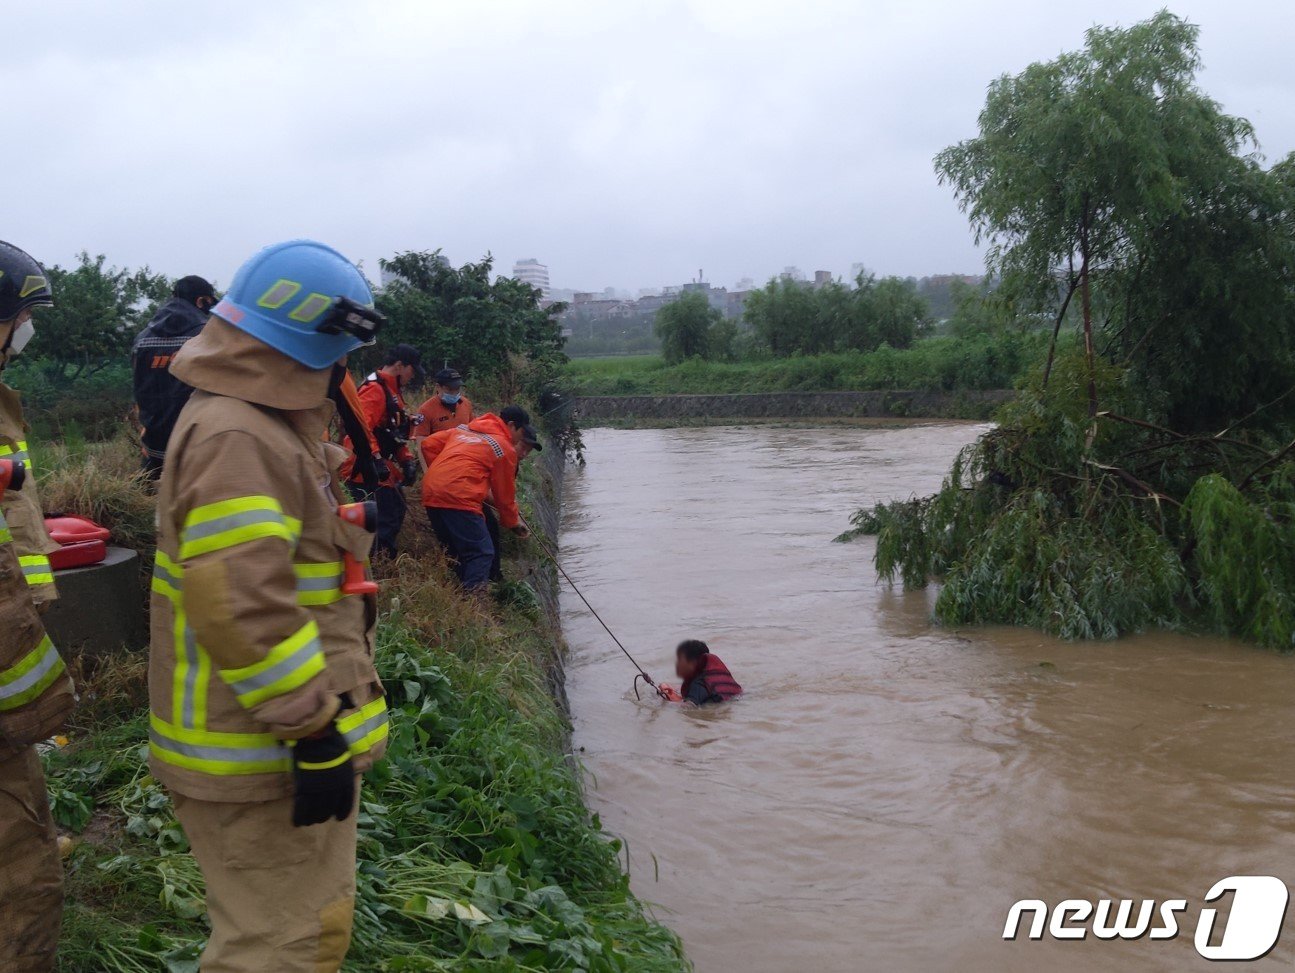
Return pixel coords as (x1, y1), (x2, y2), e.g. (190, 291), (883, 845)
(840, 359), (1295, 652)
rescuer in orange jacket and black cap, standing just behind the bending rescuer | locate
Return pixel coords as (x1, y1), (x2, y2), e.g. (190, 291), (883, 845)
(351, 345), (423, 557)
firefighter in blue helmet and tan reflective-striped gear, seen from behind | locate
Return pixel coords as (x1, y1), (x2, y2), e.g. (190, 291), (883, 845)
(149, 240), (387, 973)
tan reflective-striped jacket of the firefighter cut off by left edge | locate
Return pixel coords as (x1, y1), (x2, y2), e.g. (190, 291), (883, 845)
(0, 385), (76, 758)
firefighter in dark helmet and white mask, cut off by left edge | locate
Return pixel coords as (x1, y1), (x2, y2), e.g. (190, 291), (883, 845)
(0, 242), (76, 973)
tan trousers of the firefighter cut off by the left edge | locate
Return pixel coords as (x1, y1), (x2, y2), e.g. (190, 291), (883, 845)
(0, 746), (63, 973)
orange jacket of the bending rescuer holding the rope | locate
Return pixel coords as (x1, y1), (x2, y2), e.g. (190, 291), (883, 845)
(421, 412), (522, 529)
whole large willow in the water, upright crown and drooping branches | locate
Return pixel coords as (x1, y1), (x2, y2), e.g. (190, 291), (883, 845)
(853, 13), (1295, 650)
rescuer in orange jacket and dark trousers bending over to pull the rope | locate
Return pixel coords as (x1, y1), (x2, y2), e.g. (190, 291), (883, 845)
(420, 406), (544, 591)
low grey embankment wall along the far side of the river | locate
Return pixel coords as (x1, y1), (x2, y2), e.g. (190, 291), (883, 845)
(575, 389), (1013, 425)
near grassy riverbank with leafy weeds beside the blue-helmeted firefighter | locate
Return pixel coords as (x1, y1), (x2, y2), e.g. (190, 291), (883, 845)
(36, 441), (688, 973)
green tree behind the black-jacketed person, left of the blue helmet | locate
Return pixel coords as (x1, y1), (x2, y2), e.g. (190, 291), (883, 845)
(34, 251), (171, 381)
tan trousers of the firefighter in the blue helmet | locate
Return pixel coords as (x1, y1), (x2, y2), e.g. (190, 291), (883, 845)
(171, 781), (359, 973)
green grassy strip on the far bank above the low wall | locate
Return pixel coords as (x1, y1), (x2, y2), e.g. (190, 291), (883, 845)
(563, 334), (1046, 395)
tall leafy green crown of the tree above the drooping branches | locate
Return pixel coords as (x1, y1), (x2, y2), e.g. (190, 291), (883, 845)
(936, 12), (1291, 424)
